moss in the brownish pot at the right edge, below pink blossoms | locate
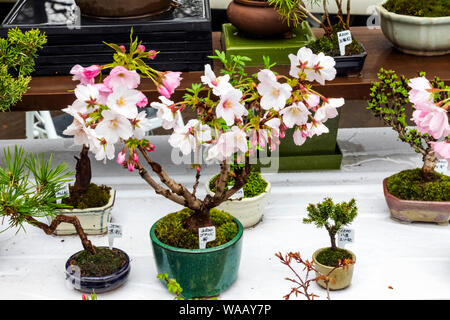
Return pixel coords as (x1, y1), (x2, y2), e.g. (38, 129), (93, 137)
(387, 169), (450, 201)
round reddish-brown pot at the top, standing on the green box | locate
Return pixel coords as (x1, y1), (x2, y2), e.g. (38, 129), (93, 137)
(227, 0), (293, 36)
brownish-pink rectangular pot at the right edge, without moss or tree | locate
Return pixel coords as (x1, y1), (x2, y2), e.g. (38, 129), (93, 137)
(383, 178), (450, 225)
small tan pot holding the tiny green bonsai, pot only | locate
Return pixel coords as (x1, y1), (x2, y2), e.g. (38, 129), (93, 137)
(313, 248), (356, 290)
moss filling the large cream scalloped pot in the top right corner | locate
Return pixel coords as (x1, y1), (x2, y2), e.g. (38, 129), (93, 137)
(383, 0), (450, 17)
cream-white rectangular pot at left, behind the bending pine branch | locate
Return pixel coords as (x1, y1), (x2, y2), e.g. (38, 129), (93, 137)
(48, 189), (116, 236)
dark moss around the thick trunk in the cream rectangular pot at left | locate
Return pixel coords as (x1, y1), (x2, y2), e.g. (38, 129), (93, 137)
(62, 183), (111, 209)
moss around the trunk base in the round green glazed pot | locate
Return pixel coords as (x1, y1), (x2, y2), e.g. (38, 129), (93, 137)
(155, 208), (238, 249)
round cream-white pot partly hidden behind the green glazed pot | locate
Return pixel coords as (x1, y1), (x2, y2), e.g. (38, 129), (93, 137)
(205, 178), (271, 228)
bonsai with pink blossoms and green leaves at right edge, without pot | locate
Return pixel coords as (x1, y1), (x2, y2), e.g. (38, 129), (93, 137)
(368, 69), (450, 186)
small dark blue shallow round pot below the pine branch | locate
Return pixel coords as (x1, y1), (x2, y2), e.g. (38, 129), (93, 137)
(66, 247), (131, 293)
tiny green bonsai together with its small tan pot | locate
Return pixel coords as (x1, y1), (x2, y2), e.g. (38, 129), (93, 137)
(303, 198), (358, 290)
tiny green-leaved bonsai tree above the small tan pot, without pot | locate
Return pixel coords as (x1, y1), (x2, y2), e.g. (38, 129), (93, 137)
(303, 198), (358, 251)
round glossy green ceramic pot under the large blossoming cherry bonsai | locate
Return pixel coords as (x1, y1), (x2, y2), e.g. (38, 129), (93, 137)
(150, 219), (244, 299)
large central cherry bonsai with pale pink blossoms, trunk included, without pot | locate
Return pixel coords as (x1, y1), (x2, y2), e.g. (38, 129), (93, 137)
(61, 37), (344, 232)
